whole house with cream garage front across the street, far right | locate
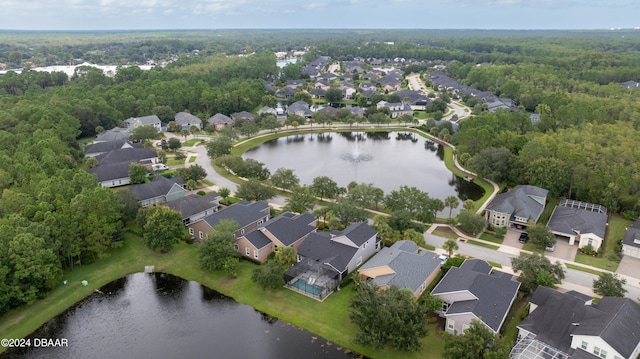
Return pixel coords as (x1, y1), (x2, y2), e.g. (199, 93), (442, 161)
(547, 199), (608, 251)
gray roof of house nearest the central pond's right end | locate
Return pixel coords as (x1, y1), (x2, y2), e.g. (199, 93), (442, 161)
(487, 185), (549, 222)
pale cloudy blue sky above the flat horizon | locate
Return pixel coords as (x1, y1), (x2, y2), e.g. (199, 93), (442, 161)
(0, 0), (640, 30)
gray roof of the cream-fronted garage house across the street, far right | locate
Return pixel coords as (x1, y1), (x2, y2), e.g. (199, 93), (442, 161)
(547, 202), (607, 239)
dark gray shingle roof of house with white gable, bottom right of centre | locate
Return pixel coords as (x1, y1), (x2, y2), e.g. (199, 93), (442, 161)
(431, 259), (520, 332)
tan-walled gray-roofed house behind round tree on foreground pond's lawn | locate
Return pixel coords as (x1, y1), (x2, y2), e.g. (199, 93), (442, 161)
(187, 201), (271, 239)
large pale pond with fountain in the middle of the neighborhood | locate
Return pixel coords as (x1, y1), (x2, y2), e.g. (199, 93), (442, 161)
(243, 132), (484, 216)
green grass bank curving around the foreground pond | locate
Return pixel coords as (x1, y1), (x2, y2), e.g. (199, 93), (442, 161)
(0, 233), (444, 358)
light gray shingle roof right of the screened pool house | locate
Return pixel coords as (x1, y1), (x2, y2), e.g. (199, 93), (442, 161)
(360, 241), (440, 292)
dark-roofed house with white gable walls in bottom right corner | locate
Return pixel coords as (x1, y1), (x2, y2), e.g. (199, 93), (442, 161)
(509, 286), (640, 359)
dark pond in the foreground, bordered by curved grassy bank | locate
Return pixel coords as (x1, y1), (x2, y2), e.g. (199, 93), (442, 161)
(0, 273), (356, 359)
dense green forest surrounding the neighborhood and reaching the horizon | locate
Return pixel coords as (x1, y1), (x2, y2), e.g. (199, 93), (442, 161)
(0, 30), (640, 313)
